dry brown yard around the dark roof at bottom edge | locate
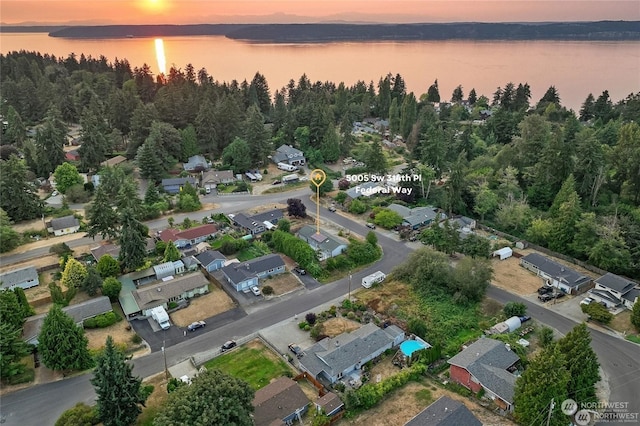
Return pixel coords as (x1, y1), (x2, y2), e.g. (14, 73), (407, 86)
(338, 380), (515, 426)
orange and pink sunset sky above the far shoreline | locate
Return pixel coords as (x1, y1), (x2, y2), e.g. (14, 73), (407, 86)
(0, 0), (640, 25)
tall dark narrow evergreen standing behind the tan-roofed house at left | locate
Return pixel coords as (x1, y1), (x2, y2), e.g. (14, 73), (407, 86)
(118, 209), (148, 270)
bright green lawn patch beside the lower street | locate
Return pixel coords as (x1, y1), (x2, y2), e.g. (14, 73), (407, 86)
(204, 340), (293, 390)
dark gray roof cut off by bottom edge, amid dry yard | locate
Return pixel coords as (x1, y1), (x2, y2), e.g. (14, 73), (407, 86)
(404, 396), (482, 426)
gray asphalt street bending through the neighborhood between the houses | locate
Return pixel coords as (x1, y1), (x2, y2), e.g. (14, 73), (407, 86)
(0, 188), (640, 426)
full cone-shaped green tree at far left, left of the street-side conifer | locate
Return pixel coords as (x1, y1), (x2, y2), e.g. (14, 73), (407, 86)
(38, 305), (93, 371)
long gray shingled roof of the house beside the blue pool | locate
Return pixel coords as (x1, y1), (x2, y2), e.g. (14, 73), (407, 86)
(300, 323), (393, 377)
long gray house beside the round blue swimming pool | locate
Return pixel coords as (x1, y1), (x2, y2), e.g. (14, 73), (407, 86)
(299, 323), (405, 384)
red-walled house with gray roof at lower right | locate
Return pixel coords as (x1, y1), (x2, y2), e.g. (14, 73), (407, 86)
(447, 338), (520, 411)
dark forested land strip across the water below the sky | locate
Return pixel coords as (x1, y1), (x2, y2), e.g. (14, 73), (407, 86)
(38, 21), (640, 43)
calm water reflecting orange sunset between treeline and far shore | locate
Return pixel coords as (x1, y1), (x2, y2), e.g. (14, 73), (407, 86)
(0, 33), (640, 110)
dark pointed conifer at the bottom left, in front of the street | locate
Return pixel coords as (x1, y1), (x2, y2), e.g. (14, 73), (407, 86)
(91, 336), (148, 426)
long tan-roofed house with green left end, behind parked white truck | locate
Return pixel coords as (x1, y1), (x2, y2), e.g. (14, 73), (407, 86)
(118, 272), (209, 318)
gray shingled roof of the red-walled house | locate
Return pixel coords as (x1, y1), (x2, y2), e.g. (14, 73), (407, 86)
(447, 338), (520, 403)
